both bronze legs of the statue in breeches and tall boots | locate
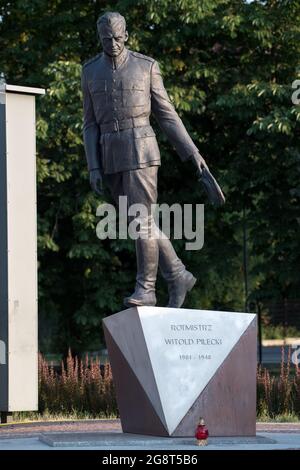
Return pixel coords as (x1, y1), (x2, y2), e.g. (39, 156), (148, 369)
(105, 166), (196, 308)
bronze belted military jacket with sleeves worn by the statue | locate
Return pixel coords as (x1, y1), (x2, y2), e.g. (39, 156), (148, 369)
(81, 48), (198, 174)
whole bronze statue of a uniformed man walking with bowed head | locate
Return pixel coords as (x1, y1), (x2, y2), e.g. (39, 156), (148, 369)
(82, 12), (223, 307)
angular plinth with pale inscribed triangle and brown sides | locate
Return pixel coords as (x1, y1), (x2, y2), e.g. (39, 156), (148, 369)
(104, 307), (256, 436)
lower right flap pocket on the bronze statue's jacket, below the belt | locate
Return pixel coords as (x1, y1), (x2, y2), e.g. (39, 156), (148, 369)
(133, 126), (160, 164)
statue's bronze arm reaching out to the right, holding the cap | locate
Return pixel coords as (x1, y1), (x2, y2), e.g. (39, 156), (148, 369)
(151, 61), (206, 173)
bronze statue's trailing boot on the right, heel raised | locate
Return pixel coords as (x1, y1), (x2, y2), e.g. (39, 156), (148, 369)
(158, 238), (197, 308)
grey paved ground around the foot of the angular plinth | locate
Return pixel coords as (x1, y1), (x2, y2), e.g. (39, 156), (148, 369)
(0, 420), (300, 451)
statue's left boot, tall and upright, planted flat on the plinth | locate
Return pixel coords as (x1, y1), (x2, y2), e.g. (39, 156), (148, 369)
(124, 238), (158, 307)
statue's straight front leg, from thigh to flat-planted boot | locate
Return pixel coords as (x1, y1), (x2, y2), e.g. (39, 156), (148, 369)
(123, 166), (159, 307)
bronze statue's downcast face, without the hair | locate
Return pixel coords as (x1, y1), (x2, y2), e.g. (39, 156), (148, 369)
(98, 22), (128, 57)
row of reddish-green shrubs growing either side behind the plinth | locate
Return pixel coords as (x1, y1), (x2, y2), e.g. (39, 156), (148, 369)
(35, 349), (300, 421)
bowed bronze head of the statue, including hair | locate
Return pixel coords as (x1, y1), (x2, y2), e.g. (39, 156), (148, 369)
(97, 12), (128, 57)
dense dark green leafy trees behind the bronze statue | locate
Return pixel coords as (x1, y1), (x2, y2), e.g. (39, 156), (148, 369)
(0, 0), (300, 351)
